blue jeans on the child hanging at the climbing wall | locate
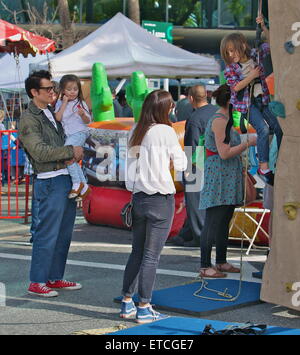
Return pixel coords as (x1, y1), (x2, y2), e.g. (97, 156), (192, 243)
(249, 99), (282, 163)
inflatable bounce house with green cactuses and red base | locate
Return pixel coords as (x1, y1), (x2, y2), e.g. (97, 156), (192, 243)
(83, 63), (186, 236)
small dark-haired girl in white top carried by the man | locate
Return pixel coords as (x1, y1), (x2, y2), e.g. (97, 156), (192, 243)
(55, 74), (91, 201)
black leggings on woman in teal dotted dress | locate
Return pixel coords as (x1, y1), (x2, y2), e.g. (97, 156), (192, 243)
(200, 205), (235, 268)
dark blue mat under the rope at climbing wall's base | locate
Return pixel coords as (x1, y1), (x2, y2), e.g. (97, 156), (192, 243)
(115, 279), (261, 316)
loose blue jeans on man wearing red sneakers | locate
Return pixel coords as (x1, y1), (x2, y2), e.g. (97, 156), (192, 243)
(30, 175), (76, 283)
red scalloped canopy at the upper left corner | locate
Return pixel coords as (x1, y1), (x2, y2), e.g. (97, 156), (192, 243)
(0, 20), (56, 57)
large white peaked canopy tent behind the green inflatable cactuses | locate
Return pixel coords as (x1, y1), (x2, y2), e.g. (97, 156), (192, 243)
(50, 13), (220, 78)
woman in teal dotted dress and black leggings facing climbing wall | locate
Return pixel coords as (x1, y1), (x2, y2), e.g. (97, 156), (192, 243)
(199, 84), (256, 278)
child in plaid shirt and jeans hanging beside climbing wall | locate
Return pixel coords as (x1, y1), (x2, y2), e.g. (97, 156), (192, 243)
(220, 16), (282, 186)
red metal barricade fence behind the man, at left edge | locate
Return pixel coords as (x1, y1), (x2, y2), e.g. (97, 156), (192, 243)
(0, 130), (30, 223)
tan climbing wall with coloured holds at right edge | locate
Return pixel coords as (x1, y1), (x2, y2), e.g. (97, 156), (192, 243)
(261, 0), (300, 310)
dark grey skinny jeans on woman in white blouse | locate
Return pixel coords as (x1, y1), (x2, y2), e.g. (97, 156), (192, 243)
(122, 192), (175, 303)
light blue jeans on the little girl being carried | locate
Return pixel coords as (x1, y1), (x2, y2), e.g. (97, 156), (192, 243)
(65, 131), (89, 184)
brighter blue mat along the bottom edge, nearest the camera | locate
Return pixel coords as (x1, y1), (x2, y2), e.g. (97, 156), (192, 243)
(110, 317), (300, 335)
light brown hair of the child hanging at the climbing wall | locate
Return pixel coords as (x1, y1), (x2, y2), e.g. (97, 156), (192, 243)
(220, 32), (251, 65)
